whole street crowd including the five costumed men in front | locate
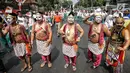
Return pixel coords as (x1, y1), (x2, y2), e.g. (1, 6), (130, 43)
(0, 8), (130, 73)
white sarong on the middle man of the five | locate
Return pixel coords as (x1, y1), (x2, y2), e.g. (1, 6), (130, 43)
(62, 44), (76, 57)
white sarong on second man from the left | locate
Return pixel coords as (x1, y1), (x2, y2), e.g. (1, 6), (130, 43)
(36, 40), (51, 56)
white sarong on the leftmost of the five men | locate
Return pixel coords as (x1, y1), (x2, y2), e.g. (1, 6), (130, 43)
(13, 43), (26, 57)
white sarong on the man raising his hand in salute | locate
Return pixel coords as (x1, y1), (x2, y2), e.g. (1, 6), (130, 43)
(88, 41), (105, 55)
